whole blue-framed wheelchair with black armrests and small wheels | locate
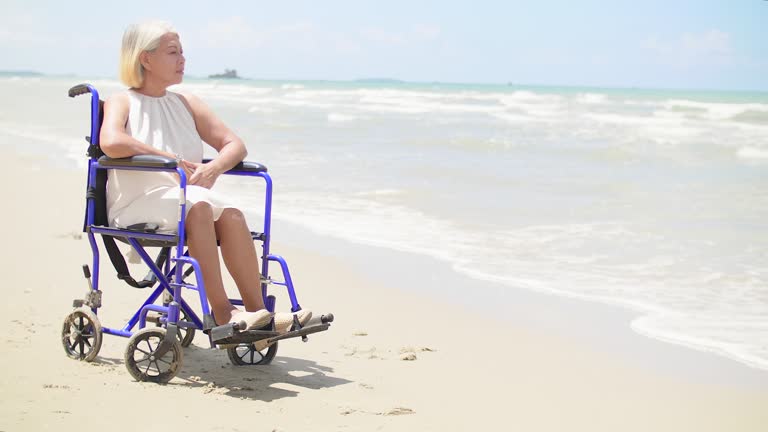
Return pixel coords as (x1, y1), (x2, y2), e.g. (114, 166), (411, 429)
(61, 84), (333, 383)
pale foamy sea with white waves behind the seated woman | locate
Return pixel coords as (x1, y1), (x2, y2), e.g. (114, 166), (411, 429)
(0, 75), (768, 370)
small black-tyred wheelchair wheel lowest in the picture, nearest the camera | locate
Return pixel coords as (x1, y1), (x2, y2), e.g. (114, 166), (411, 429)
(125, 327), (184, 384)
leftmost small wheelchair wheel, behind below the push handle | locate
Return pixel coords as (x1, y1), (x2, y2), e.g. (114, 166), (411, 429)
(61, 307), (102, 362)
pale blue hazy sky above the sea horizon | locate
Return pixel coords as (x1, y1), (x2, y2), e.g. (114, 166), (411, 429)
(0, 0), (768, 91)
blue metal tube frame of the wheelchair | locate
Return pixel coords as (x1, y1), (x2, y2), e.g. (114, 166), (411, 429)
(65, 84), (333, 379)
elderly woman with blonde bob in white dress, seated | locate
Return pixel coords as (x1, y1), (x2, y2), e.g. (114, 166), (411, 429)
(100, 21), (312, 331)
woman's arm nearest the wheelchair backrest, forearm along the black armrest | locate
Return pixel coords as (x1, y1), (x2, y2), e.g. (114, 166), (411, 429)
(99, 93), (176, 159)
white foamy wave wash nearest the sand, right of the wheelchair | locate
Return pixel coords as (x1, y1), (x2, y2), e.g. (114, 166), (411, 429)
(238, 184), (768, 368)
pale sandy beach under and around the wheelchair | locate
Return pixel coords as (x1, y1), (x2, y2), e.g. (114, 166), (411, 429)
(0, 148), (768, 432)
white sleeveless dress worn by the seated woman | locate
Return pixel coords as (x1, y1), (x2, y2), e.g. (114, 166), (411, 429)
(107, 90), (236, 233)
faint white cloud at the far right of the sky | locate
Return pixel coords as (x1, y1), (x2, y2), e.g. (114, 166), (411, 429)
(643, 30), (733, 68)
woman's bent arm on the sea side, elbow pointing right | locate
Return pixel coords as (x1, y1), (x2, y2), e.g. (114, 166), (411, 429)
(182, 94), (248, 188)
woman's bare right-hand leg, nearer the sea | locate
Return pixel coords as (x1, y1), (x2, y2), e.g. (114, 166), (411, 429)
(214, 208), (265, 312)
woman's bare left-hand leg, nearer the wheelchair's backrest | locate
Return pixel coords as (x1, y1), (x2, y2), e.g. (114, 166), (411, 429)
(185, 202), (237, 325)
